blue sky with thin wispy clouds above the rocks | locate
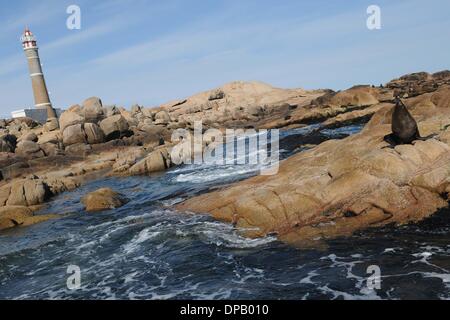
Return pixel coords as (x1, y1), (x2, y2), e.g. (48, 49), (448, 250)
(0, 0), (450, 116)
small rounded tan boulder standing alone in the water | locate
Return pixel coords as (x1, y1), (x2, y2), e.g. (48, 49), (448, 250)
(81, 188), (127, 212)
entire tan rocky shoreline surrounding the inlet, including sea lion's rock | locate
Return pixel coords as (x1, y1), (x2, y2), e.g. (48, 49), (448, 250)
(0, 71), (450, 245)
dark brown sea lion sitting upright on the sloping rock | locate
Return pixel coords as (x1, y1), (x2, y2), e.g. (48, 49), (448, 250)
(390, 97), (421, 144)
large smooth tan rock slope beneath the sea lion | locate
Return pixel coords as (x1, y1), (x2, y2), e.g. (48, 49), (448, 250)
(178, 86), (450, 245)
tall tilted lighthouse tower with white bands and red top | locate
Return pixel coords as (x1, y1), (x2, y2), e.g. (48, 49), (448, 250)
(21, 28), (59, 131)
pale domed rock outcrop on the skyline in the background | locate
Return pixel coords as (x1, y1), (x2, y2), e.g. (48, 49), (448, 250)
(162, 81), (325, 128)
